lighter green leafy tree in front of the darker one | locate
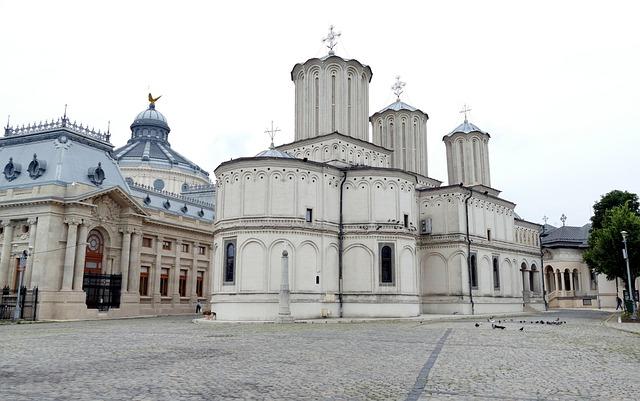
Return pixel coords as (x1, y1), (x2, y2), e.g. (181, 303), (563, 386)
(583, 203), (640, 290)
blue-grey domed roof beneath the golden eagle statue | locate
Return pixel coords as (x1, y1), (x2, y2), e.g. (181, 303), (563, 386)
(114, 103), (209, 177)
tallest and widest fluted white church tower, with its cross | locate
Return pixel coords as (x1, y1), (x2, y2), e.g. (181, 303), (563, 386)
(291, 26), (373, 141)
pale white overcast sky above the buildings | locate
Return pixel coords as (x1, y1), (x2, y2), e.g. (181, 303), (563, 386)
(0, 0), (640, 225)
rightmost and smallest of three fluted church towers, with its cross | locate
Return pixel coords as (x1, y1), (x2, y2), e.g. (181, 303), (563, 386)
(442, 105), (491, 187)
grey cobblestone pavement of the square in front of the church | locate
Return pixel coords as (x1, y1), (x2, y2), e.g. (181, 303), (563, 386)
(0, 311), (640, 401)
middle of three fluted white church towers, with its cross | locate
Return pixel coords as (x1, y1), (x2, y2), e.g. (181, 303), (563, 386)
(369, 76), (429, 177)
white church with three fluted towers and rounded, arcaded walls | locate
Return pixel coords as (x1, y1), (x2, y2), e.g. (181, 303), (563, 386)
(211, 30), (544, 320)
